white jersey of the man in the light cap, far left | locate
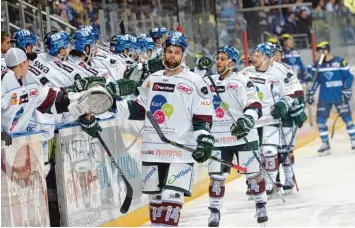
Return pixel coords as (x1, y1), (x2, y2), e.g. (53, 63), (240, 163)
(1, 69), (57, 133)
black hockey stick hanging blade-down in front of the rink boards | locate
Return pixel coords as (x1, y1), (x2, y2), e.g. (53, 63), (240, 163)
(87, 114), (133, 214)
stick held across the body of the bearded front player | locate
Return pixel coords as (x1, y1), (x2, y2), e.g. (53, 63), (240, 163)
(147, 111), (247, 172)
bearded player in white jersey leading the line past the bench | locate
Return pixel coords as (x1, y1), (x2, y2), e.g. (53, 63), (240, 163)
(117, 32), (214, 226)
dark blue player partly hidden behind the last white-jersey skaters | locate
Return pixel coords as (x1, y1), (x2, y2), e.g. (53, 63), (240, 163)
(281, 34), (307, 83)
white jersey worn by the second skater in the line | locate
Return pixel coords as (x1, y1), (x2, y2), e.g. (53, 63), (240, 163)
(206, 73), (262, 147)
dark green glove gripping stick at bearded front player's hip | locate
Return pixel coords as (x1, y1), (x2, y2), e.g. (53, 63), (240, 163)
(192, 135), (215, 163)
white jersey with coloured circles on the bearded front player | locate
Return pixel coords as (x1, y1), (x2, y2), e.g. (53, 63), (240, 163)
(117, 70), (213, 163)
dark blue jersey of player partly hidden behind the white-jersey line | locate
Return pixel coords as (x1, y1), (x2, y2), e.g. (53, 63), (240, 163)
(284, 49), (305, 83)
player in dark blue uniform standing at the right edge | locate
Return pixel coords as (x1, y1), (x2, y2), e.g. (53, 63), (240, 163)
(307, 41), (355, 155)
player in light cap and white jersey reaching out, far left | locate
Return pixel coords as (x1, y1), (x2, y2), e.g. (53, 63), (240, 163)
(1, 48), (112, 137)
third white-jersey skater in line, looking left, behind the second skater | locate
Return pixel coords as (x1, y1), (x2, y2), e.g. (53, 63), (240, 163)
(241, 43), (294, 195)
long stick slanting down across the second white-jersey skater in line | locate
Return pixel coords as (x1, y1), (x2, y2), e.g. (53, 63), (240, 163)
(206, 75), (286, 203)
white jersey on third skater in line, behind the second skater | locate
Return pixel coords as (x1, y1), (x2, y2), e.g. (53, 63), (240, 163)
(240, 66), (294, 128)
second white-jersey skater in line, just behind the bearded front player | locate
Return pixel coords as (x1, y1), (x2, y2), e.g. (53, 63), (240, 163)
(205, 46), (268, 227)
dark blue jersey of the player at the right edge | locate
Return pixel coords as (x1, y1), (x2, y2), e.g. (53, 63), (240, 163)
(311, 56), (354, 104)
